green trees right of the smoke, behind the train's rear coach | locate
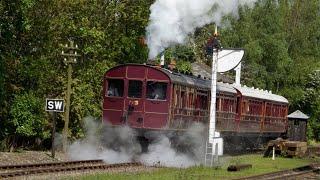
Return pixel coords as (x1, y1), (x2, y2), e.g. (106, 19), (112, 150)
(193, 0), (320, 138)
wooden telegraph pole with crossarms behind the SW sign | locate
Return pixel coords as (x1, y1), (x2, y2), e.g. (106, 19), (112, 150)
(61, 40), (80, 152)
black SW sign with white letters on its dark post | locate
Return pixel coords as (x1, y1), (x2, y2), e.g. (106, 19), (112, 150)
(46, 99), (64, 158)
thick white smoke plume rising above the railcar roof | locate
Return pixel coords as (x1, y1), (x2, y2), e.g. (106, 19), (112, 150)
(146, 0), (255, 59)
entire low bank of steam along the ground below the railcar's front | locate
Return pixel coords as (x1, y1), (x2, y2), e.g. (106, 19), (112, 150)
(68, 117), (205, 168)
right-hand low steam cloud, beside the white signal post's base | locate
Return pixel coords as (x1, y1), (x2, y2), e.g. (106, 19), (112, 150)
(139, 123), (205, 168)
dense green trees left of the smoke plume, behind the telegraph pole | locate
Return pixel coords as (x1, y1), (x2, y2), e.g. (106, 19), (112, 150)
(0, 0), (152, 149)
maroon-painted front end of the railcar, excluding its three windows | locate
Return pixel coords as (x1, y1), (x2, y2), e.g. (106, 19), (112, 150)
(103, 64), (171, 129)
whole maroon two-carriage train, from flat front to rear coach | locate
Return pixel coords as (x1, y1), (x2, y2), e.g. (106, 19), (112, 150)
(103, 64), (288, 147)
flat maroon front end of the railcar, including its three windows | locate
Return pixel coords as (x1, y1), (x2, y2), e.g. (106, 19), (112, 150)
(103, 65), (172, 129)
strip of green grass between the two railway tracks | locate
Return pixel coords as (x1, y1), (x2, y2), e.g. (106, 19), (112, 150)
(69, 154), (315, 180)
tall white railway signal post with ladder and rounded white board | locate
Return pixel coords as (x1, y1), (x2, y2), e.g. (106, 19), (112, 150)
(205, 27), (244, 165)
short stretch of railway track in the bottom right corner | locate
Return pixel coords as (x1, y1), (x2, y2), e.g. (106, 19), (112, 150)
(237, 164), (320, 180)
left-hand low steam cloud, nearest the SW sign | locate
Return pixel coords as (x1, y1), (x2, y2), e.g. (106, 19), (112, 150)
(68, 117), (137, 164)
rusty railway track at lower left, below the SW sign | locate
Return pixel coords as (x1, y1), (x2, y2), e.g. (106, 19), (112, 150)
(0, 160), (141, 179)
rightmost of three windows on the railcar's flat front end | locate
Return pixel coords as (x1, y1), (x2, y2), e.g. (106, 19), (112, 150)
(147, 81), (167, 100)
